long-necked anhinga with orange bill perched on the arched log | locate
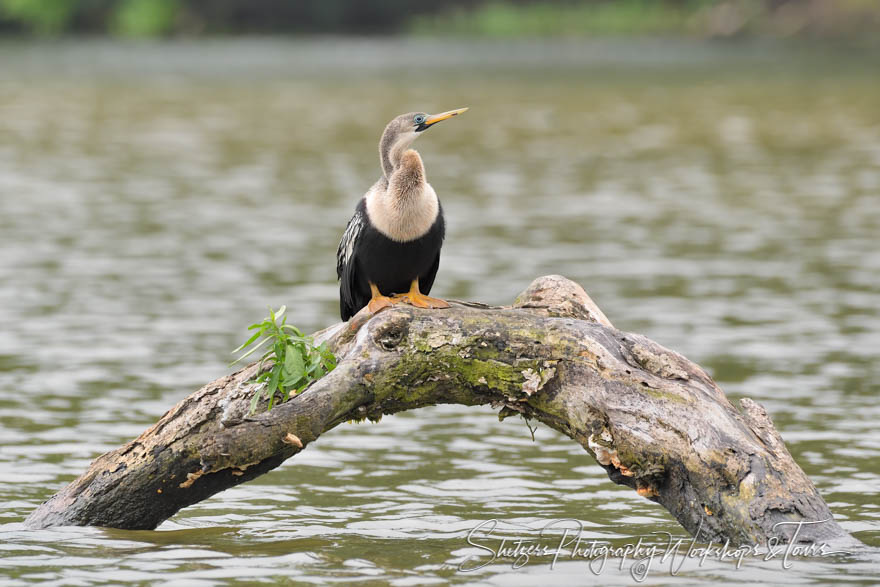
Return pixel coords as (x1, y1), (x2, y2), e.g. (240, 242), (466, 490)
(336, 108), (467, 320)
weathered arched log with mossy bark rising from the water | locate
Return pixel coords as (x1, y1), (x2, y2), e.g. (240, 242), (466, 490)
(27, 276), (855, 544)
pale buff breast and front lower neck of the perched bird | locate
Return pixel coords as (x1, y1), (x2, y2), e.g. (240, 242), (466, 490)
(367, 149), (440, 242)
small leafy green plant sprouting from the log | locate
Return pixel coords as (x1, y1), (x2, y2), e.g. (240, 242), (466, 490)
(230, 306), (336, 414)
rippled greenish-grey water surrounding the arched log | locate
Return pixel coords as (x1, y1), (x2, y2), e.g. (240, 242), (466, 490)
(0, 41), (880, 585)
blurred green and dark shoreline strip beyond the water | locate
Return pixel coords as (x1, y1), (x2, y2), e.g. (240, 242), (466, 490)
(0, 0), (880, 40)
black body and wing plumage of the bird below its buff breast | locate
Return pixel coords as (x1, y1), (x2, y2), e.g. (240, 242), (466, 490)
(336, 198), (446, 320)
